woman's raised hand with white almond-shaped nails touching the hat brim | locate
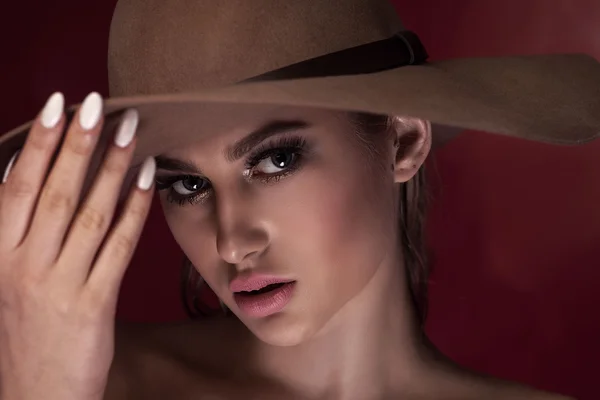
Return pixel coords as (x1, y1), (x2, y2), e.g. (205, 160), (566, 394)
(0, 93), (155, 400)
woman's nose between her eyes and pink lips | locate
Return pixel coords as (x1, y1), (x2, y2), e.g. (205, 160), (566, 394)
(216, 191), (269, 264)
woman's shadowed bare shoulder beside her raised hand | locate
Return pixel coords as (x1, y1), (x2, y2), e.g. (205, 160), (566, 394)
(105, 318), (246, 400)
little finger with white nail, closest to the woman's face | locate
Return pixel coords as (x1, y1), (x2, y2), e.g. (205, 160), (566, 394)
(86, 157), (156, 303)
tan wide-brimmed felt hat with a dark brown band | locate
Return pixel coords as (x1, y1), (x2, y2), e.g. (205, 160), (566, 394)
(0, 0), (600, 167)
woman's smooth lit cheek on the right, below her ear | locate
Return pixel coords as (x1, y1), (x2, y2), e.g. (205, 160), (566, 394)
(279, 157), (395, 306)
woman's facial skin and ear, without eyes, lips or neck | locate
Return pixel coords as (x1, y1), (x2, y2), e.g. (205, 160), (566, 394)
(157, 111), (422, 346)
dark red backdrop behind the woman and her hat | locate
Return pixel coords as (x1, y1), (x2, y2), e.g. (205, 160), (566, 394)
(0, 0), (600, 399)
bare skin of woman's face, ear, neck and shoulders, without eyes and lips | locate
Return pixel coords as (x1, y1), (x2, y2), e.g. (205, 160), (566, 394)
(109, 109), (572, 399)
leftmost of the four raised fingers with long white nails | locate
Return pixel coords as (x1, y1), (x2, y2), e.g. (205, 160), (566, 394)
(0, 92), (65, 248)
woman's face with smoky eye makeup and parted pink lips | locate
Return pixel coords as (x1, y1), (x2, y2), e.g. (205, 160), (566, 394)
(157, 109), (426, 345)
